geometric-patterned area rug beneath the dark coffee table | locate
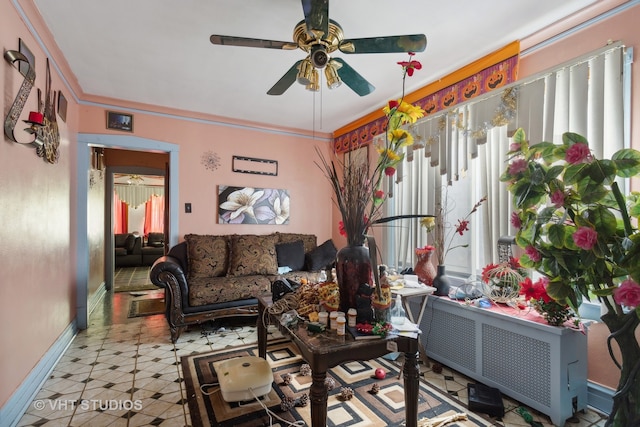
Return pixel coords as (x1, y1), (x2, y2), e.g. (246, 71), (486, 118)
(182, 340), (493, 427)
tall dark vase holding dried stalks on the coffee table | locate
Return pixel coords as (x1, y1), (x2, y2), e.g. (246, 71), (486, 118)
(336, 245), (373, 313)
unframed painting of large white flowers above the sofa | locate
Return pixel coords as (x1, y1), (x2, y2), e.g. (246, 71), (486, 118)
(218, 185), (289, 225)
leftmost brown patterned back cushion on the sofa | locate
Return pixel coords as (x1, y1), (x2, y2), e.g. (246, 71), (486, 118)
(184, 234), (229, 280)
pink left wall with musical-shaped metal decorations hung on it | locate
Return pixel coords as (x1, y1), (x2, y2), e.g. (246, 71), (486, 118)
(0, 2), (78, 408)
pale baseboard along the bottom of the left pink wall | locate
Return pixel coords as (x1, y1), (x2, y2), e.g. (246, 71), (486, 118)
(0, 319), (78, 427)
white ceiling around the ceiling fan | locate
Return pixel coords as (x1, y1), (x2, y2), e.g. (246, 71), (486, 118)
(34, 0), (595, 133)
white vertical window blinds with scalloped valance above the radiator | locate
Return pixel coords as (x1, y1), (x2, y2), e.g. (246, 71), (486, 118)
(382, 45), (628, 274)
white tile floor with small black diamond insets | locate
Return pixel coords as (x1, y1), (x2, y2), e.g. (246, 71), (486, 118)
(12, 290), (604, 427)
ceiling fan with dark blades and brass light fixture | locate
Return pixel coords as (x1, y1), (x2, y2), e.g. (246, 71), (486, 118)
(209, 0), (427, 96)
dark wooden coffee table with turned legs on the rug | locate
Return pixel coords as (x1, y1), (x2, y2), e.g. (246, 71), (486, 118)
(258, 294), (420, 427)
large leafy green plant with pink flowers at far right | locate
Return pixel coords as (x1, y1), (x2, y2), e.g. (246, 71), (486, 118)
(501, 129), (640, 427)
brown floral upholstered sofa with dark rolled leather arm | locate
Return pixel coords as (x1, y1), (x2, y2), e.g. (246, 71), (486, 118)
(150, 233), (336, 342)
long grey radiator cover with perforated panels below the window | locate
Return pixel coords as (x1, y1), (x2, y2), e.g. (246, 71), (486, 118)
(420, 296), (587, 426)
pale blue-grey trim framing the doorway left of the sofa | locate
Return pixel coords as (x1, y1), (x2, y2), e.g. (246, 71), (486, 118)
(76, 133), (180, 329)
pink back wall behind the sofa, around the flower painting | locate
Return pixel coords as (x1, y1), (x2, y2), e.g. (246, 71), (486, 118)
(80, 106), (331, 243)
